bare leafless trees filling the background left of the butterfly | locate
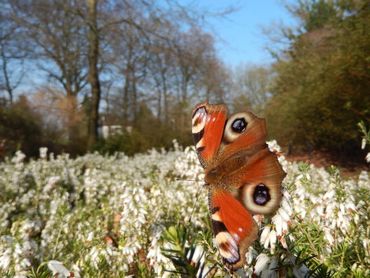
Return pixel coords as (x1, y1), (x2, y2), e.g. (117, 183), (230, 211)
(0, 0), (228, 154)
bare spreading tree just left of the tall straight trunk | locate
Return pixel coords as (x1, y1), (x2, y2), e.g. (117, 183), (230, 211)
(9, 0), (87, 141)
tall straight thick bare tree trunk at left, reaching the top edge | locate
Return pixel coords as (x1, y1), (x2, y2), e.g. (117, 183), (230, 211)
(87, 0), (101, 151)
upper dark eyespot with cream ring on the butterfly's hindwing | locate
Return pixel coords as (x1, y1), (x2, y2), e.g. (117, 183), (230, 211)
(224, 113), (250, 143)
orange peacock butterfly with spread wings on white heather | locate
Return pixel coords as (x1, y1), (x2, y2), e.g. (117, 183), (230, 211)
(192, 102), (285, 270)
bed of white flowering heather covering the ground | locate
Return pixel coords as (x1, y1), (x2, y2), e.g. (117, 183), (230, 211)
(0, 142), (370, 277)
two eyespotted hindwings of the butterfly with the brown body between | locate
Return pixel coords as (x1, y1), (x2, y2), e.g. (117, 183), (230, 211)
(212, 109), (285, 214)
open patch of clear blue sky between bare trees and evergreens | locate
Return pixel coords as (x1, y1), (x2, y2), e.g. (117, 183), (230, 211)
(189, 0), (295, 66)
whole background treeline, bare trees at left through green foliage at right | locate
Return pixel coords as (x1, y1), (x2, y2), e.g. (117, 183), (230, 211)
(0, 0), (370, 162)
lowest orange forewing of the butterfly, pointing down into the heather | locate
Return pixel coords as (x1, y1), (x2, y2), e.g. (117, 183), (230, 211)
(209, 189), (258, 270)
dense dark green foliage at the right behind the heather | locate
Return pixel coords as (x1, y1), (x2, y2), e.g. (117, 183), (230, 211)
(266, 1), (370, 158)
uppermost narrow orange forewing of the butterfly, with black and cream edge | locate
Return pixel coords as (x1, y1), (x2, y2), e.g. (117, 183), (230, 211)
(192, 103), (227, 168)
